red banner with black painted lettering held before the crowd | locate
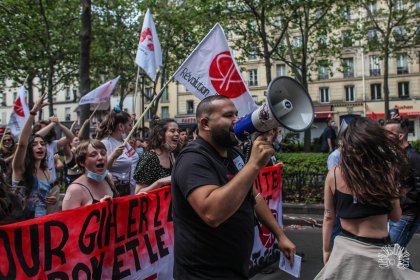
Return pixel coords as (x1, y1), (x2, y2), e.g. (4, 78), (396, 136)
(0, 165), (282, 280)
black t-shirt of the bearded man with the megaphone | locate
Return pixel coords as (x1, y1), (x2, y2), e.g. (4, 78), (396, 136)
(172, 139), (255, 280)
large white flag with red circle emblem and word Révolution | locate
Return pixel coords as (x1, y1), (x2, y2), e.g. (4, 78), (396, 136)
(174, 23), (257, 117)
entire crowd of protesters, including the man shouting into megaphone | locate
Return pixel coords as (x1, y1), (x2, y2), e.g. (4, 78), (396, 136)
(0, 93), (420, 279)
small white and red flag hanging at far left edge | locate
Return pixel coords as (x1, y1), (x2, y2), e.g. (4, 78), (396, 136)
(7, 86), (29, 139)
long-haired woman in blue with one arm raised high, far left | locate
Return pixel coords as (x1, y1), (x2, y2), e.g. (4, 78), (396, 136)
(12, 94), (57, 218)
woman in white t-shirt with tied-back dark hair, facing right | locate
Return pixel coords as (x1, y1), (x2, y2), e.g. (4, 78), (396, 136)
(97, 107), (139, 196)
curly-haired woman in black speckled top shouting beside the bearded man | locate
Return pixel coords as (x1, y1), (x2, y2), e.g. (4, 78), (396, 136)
(134, 119), (179, 194)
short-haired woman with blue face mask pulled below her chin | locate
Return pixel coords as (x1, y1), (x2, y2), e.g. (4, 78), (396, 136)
(63, 139), (118, 210)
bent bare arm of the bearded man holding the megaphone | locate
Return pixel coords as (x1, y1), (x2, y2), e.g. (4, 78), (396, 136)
(187, 136), (274, 227)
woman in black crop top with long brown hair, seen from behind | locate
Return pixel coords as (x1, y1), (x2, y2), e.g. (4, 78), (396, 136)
(315, 117), (419, 279)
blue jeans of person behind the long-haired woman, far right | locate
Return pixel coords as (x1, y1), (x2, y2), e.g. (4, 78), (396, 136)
(389, 218), (420, 248)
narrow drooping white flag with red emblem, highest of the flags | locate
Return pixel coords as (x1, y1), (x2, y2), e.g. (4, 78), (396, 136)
(136, 9), (162, 81)
